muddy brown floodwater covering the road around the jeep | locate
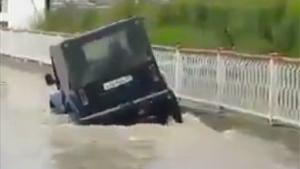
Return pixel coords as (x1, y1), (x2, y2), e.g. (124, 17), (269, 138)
(0, 55), (300, 169)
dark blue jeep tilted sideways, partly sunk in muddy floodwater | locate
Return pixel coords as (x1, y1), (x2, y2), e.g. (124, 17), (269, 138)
(45, 17), (182, 125)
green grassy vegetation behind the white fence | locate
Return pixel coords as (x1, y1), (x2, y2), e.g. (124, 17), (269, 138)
(33, 0), (300, 57)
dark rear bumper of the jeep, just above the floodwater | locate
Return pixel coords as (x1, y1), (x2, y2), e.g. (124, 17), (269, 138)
(80, 89), (178, 124)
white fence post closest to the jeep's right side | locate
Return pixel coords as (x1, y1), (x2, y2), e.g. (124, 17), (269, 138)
(175, 47), (183, 94)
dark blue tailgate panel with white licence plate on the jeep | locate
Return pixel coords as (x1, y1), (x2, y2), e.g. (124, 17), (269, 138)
(84, 62), (167, 114)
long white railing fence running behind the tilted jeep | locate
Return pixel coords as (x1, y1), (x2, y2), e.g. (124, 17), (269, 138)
(0, 30), (300, 126)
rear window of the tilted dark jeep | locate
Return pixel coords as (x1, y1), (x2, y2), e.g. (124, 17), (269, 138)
(65, 20), (149, 87)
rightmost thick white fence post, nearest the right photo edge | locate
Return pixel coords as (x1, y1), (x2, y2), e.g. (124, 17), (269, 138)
(268, 57), (275, 125)
